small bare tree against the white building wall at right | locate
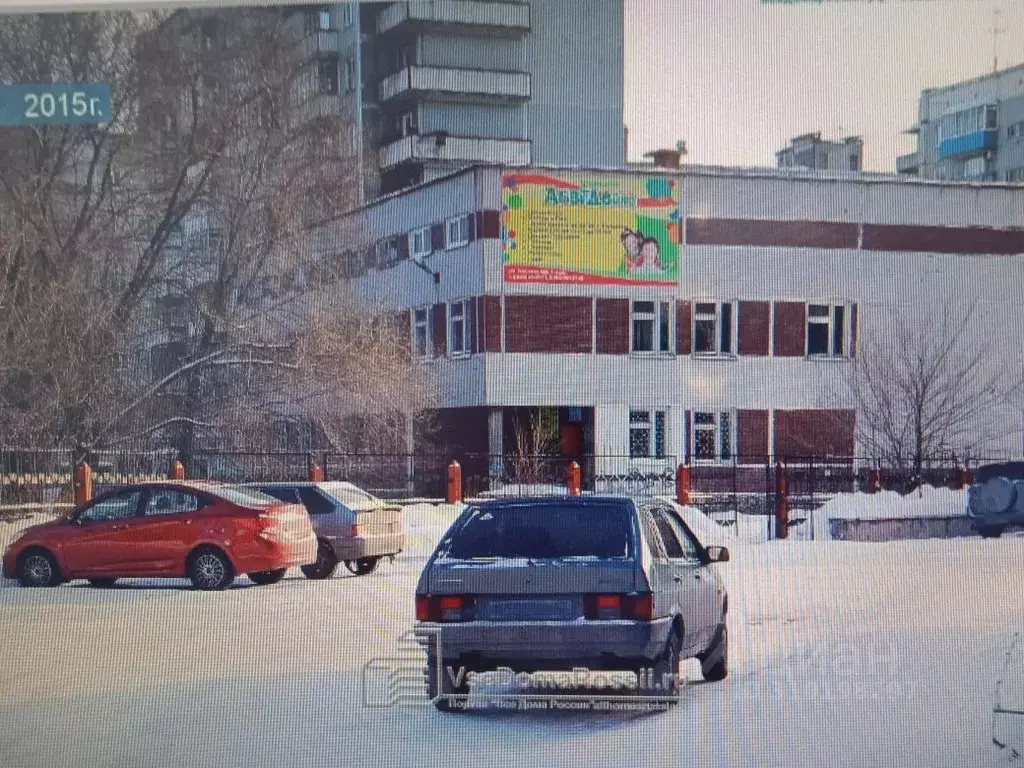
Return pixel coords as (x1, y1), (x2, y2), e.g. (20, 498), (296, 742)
(835, 301), (1022, 483)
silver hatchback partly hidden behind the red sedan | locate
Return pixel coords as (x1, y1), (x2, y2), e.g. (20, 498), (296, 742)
(249, 481), (406, 579)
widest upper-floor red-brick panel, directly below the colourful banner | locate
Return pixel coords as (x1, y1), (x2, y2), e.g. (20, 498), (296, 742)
(505, 296), (594, 353)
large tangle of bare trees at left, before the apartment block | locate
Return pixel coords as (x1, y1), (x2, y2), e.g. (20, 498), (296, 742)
(0, 8), (429, 454)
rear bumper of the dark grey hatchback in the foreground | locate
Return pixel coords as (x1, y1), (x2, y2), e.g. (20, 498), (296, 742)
(415, 617), (672, 668)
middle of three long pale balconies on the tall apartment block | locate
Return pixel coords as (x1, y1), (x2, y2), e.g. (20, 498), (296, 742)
(380, 67), (529, 102)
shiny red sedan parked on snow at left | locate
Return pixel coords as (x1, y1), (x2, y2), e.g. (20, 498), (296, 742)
(3, 482), (316, 590)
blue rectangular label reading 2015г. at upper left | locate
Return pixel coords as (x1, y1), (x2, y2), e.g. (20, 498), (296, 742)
(0, 83), (111, 125)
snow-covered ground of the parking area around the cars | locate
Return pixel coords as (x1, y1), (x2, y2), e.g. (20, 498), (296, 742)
(0, 505), (1024, 768)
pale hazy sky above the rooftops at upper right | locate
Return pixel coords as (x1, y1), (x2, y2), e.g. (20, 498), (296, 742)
(624, 0), (1024, 172)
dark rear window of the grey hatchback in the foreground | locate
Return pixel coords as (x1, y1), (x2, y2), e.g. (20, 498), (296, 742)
(441, 502), (631, 560)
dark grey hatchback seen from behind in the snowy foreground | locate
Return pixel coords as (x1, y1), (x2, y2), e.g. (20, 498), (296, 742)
(415, 497), (729, 712)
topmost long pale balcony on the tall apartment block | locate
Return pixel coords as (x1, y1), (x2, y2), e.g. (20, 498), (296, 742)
(377, 0), (529, 37)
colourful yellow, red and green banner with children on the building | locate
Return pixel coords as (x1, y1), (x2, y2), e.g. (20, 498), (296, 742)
(502, 171), (680, 286)
